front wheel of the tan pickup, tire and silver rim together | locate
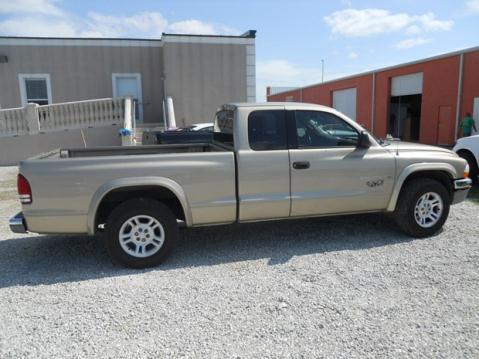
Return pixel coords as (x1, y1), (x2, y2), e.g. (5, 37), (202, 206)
(393, 178), (451, 238)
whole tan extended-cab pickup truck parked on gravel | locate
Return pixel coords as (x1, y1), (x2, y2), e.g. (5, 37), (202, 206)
(10, 103), (471, 268)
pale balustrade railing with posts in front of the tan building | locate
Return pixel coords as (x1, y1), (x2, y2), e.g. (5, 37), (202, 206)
(0, 98), (134, 137)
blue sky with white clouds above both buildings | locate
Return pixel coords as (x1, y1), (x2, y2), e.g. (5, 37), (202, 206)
(0, 0), (479, 101)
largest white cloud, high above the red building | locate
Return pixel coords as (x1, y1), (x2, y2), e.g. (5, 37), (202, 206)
(324, 9), (454, 37)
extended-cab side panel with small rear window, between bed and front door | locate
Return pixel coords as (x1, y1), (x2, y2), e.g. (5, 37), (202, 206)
(237, 106), (291, 221)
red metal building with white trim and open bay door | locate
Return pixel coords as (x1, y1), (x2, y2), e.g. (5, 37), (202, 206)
(267, 47), (479, 145)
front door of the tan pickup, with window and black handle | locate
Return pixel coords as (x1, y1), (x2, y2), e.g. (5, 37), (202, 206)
(289, 110), (395, 216)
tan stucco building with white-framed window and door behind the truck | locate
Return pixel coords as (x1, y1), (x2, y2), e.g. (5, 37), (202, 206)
(0, 30), (256, 126)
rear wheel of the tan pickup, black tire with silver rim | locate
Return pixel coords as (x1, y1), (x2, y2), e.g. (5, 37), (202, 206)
(105, 198), (179, 268)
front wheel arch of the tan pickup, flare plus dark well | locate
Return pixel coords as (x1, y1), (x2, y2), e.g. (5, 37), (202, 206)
(386, 163), (458, 212)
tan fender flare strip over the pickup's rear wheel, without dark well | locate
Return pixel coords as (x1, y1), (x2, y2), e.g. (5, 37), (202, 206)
(87, 177), (192, 235)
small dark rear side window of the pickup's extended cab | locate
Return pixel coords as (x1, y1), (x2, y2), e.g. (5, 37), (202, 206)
(248, 110), (287, 151)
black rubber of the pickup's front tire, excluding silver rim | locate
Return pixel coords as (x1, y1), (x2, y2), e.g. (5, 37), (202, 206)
(393, 178), (451, 238)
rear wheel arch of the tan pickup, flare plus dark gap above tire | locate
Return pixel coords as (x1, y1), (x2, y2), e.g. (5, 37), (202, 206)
(87, 177), (192, 235)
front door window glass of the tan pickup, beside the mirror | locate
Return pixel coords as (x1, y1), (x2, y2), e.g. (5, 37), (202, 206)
(295, 111), (358, 148)
